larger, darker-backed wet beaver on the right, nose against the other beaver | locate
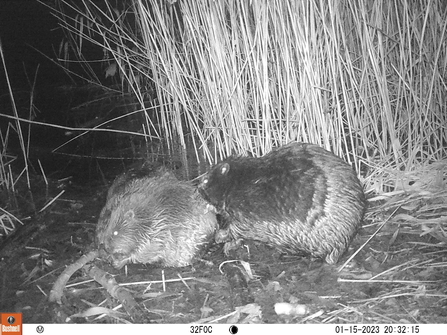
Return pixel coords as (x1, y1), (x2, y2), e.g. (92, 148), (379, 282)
(199, 143), (366, 264)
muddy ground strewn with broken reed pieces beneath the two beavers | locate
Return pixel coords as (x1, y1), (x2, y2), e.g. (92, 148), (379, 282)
(0, 167), (447, 323)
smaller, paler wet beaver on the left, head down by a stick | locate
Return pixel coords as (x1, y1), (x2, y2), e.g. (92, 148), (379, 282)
(96, 169), (218, 268)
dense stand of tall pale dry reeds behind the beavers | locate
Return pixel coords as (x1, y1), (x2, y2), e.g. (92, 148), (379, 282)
(47, 0), (447, 192)
